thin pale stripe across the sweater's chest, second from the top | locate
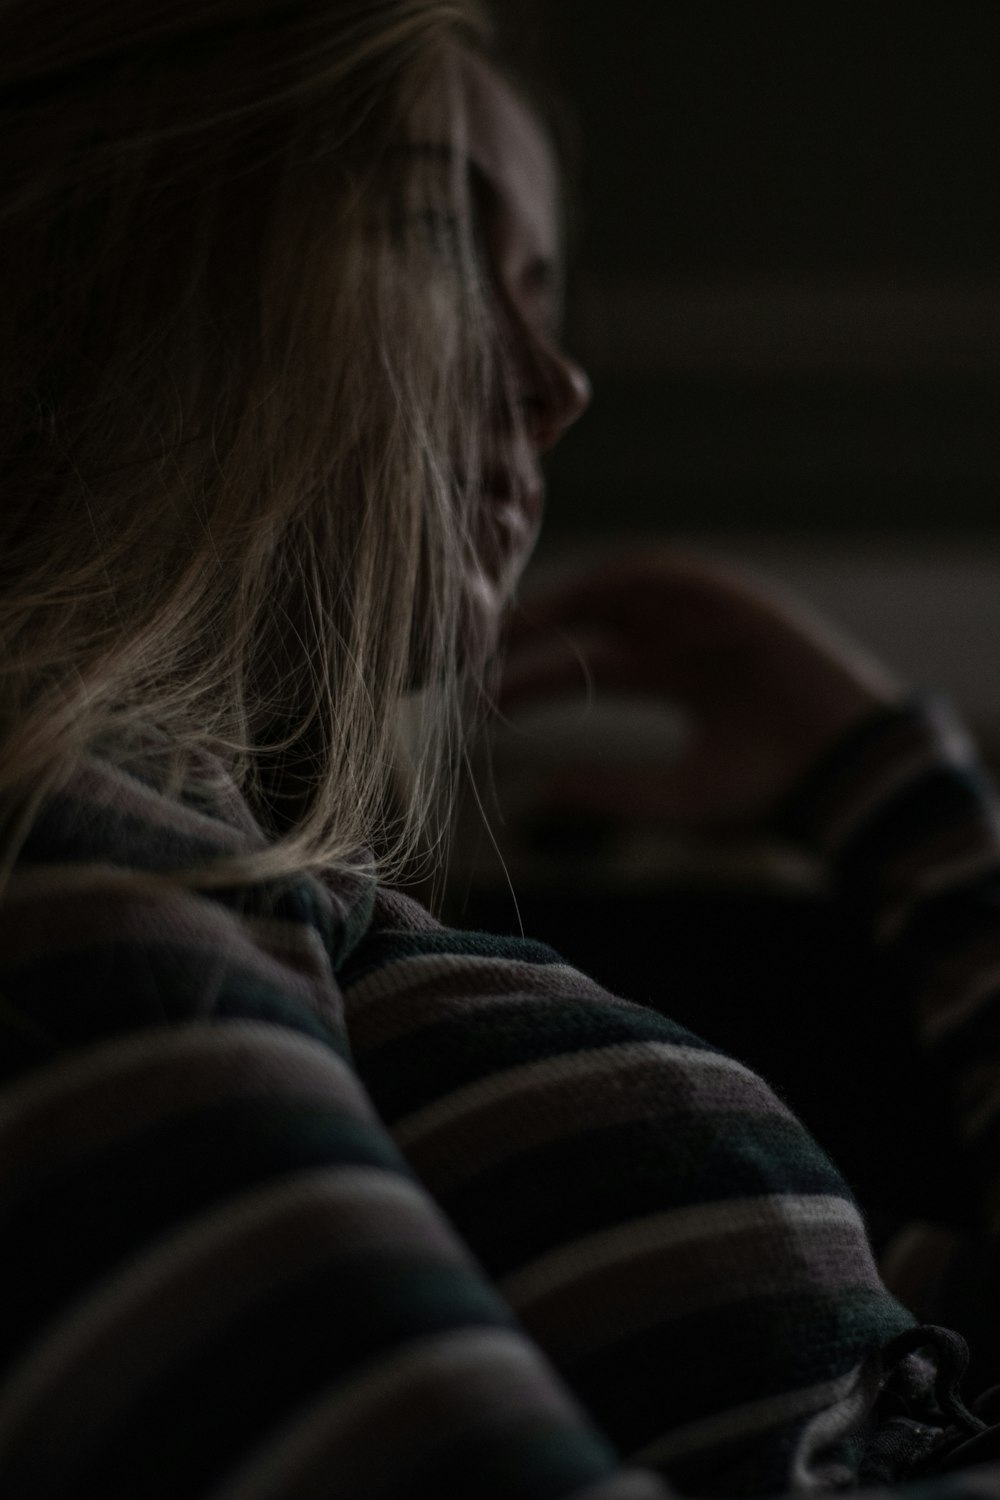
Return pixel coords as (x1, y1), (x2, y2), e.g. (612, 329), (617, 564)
(393, 1041), (767, 1148)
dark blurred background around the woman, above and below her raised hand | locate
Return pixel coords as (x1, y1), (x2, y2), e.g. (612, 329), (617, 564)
(451, 0), (1000, 1242)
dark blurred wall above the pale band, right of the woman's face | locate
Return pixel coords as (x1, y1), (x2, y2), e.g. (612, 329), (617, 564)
(498, 0), (1000, 543)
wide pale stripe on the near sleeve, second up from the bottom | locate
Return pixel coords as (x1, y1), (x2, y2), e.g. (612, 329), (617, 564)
(0, 1167), (469, 1463)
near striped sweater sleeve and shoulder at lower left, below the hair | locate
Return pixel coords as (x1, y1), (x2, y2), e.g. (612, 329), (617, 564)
(0, 762), (667, 1500)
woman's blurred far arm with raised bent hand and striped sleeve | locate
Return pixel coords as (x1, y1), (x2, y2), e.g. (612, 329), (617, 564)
(505, 554), (1000, 1383)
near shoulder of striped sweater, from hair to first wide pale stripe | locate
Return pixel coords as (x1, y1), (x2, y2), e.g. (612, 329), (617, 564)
(0, 756), (366, 1076)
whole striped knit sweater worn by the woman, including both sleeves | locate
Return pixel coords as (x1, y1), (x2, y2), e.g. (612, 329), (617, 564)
(0, 707), (1000, 1500)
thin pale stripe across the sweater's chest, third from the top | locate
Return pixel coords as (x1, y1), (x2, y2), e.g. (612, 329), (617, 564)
(498, 1193), (874, 1314)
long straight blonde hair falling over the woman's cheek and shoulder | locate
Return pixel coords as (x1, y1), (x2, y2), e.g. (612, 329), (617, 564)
(0, 0), (496, 885)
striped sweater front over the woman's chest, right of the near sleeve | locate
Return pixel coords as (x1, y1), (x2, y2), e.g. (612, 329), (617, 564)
(342, 899), (947, 1496)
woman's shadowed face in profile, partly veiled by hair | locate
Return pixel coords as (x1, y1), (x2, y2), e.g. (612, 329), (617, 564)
(443, 51), (589, 623)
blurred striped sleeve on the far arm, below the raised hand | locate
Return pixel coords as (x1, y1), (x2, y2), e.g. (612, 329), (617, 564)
(784, 701), (1000, 1388)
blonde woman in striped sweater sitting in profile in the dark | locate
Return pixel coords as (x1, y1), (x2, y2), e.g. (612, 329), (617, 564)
(0, 0), (996, 1500)
